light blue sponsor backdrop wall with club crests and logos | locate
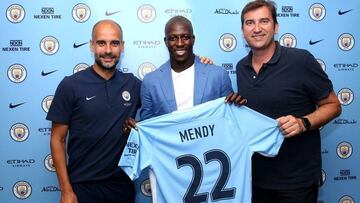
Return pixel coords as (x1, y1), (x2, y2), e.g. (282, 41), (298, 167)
(0, 0), (360, 203)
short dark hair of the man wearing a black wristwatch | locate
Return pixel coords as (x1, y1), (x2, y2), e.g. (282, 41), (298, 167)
(241, 0), (278, 27)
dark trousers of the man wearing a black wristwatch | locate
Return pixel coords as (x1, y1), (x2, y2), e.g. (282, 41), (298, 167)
(252, 184), (319, 203)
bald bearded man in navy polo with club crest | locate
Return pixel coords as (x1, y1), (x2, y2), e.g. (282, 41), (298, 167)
(47, 20), (141, 203)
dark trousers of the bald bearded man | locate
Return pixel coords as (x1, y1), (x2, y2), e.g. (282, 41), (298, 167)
(72, 180), (135, 203)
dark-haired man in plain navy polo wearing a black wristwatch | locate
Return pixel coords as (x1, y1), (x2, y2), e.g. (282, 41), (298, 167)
(236, 0), (341, 203)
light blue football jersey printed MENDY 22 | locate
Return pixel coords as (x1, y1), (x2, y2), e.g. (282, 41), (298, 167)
(119, 98), (284, 203)
